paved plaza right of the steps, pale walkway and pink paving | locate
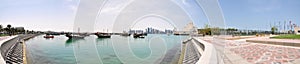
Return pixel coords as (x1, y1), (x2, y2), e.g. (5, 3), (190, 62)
(201, 37), (300, 64)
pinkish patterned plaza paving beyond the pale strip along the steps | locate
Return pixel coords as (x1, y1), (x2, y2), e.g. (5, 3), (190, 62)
(202, 38), (300, 64)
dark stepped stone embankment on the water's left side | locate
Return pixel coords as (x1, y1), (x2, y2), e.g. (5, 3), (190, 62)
(0, 34), (35, 64)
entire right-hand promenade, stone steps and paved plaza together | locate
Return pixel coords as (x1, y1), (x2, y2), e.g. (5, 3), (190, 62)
(182, 36), (300, 64)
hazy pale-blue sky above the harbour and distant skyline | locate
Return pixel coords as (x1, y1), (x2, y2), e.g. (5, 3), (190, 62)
(0, 0), (300, 32)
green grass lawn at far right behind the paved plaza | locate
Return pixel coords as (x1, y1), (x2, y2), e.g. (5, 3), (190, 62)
(271, 34), (300, 39)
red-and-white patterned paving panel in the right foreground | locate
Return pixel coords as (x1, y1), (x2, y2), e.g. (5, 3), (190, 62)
(230, 44), (300, 64)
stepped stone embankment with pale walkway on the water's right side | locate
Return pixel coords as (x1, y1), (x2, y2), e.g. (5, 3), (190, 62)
(179, 37), (224, 64)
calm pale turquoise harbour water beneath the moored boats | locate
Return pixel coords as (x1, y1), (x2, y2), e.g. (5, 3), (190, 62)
(26, 35), (187, 64)
